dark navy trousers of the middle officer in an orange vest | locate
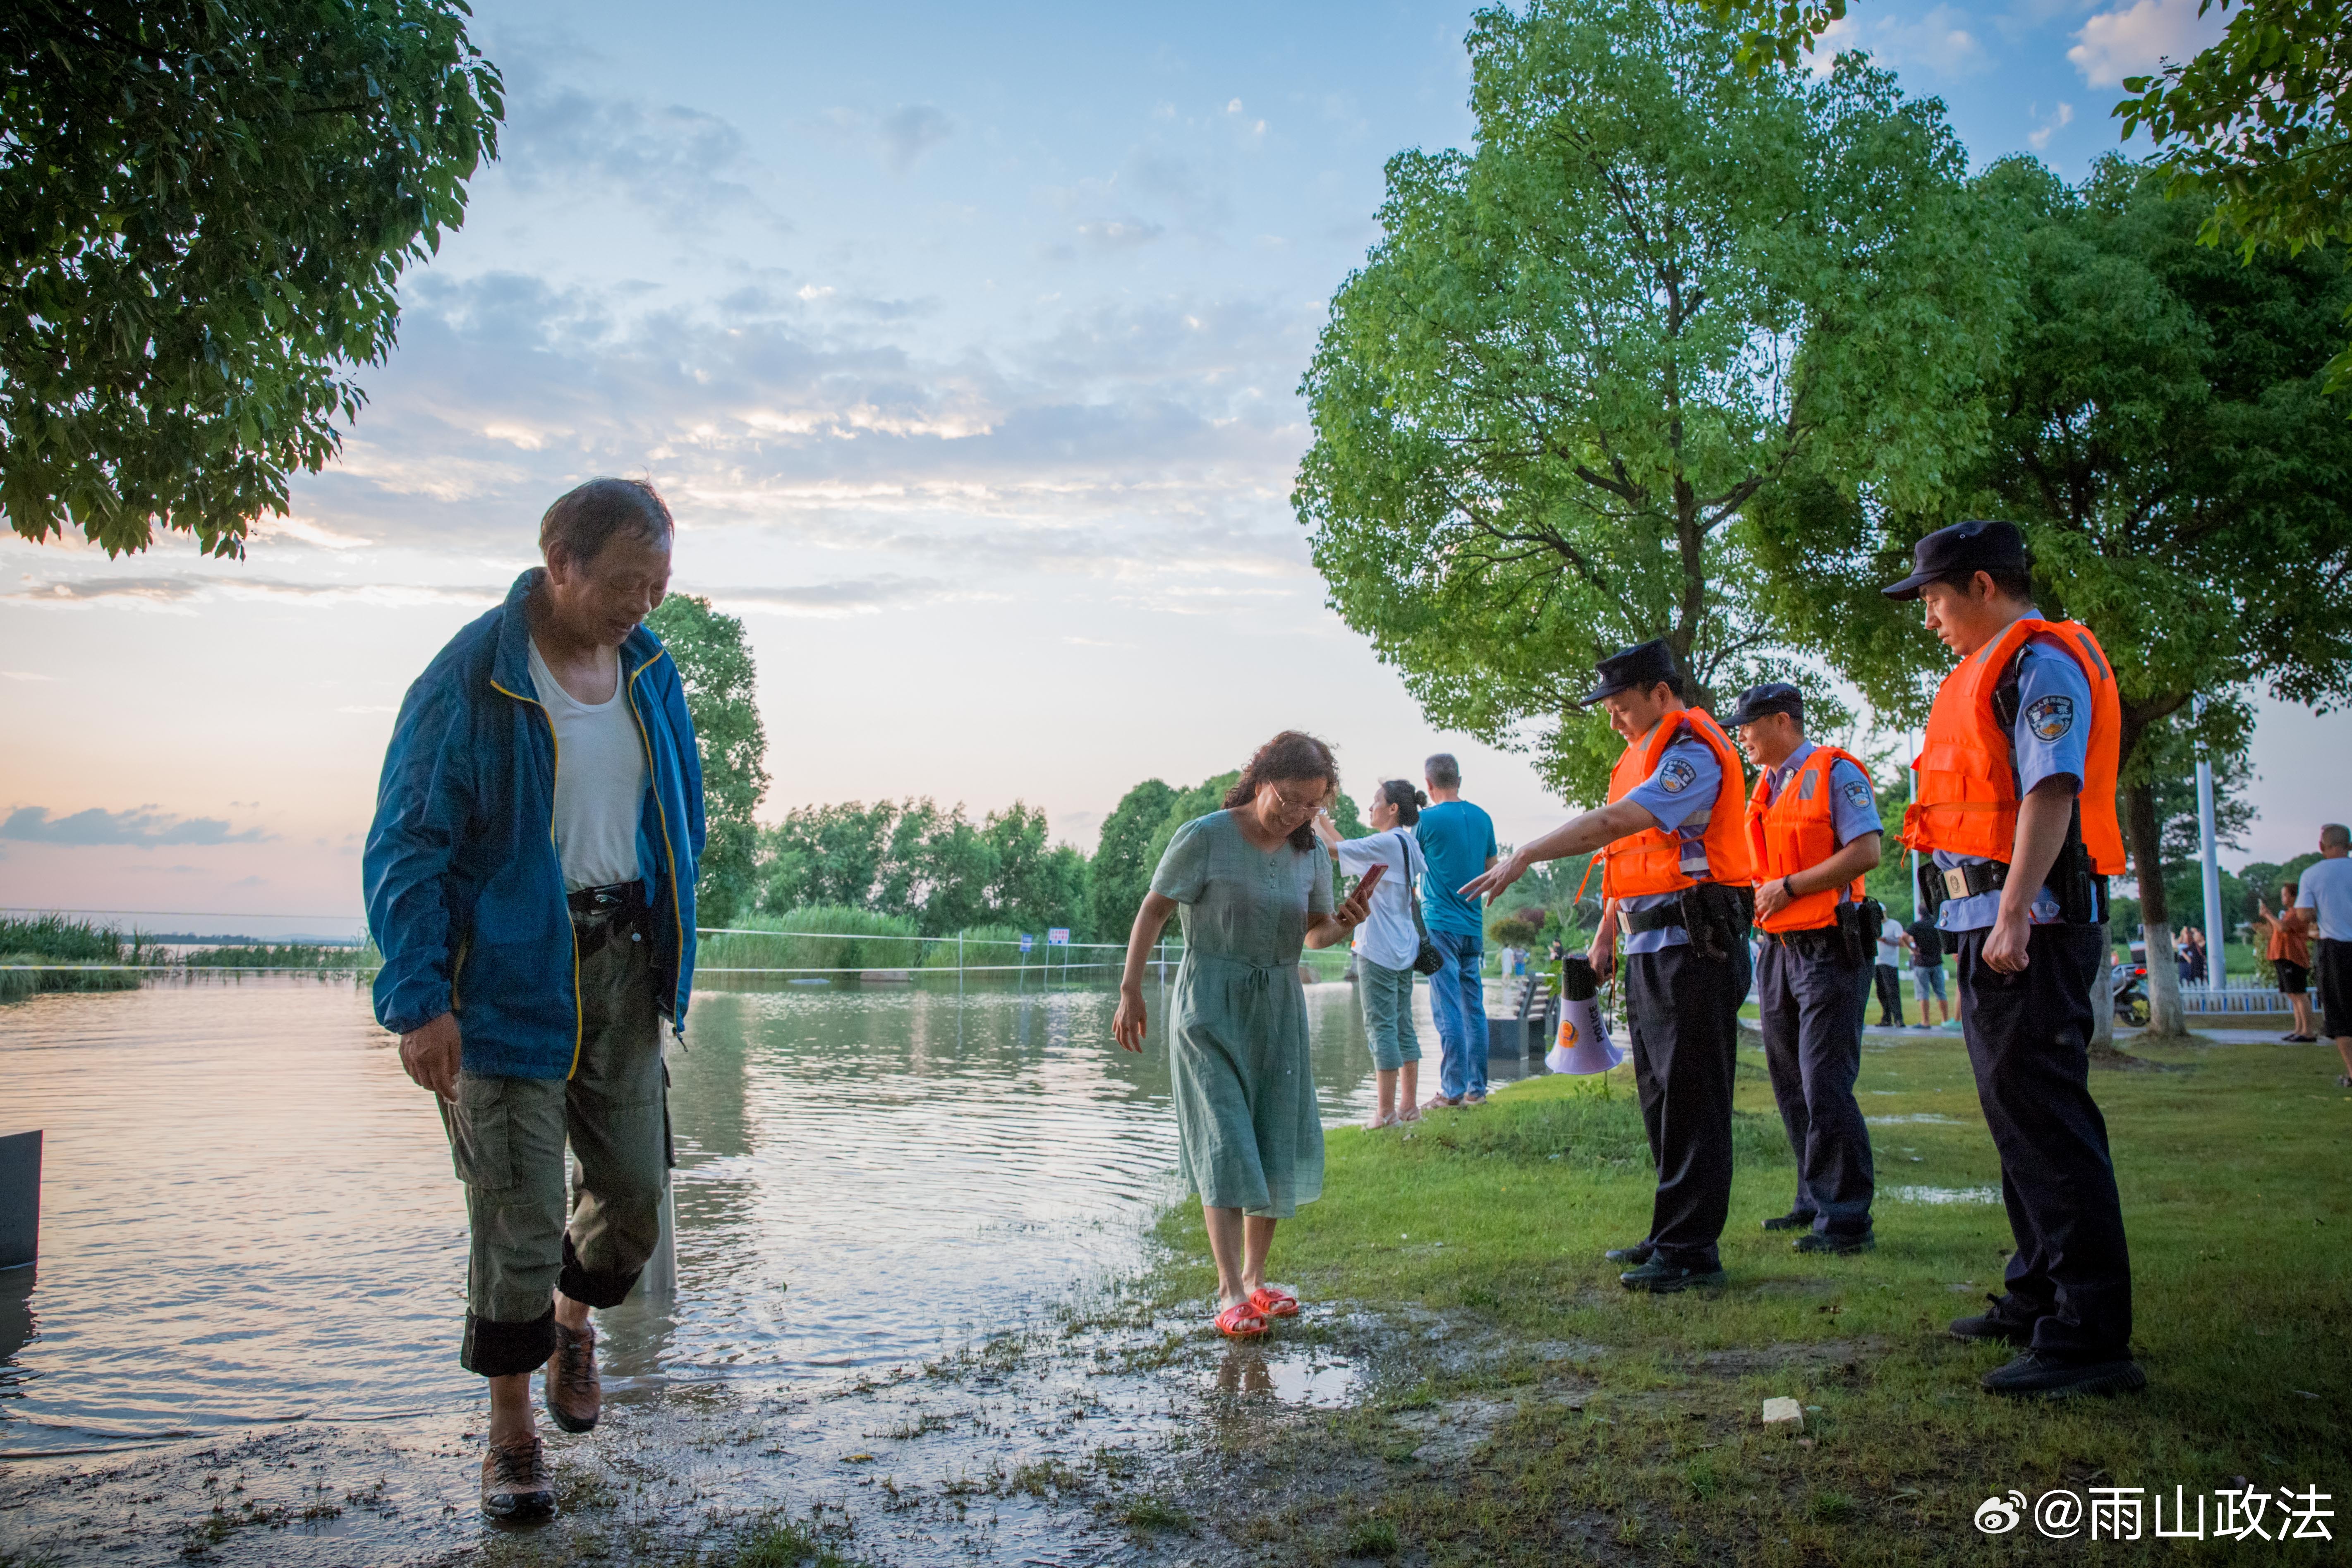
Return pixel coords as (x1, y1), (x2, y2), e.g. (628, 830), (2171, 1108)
(1757, 933), (1872, 1237)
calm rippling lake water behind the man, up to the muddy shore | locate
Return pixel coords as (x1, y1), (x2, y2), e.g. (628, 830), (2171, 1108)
(0, 978), (1435, 1453)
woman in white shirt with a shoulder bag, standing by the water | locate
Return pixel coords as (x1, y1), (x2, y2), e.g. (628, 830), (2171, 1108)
(1315, 778), (1430, 1128)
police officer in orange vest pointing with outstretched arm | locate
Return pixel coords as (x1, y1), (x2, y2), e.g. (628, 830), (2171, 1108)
(1463, 642), (1752, 1290)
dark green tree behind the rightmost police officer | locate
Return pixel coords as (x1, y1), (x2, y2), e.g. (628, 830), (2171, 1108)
(1759, 158), (2352, 1032)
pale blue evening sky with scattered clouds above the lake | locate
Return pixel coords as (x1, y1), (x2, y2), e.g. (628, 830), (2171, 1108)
(0, 0), (2352, 914)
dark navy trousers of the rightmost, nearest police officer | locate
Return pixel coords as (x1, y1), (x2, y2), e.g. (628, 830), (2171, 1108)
(1959, 926), (2131, 1356)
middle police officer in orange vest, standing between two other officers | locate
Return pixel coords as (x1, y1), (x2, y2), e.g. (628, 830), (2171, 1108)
(1731, 682), (1882, 1253)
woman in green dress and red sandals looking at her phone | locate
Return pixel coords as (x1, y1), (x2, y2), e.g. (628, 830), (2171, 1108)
(1112, 729), (1378, 1338)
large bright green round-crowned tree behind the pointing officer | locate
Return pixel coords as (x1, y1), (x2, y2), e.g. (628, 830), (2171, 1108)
(1293, 0), (2013, 799)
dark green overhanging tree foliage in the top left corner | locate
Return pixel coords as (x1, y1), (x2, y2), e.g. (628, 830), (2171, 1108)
(0, 0), (503, 555)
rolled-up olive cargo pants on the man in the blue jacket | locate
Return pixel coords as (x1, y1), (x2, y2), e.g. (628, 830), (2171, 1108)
(440, 926), (671, 1378)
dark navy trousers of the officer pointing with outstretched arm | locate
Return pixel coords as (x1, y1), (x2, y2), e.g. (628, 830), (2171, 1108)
(1625, 940), (1750, 1269)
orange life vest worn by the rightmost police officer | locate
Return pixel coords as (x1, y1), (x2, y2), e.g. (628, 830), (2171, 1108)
(1903, 616), (2124, 877)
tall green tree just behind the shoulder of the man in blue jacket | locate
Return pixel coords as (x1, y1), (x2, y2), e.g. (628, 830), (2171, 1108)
(644, 592), (767, 926)
